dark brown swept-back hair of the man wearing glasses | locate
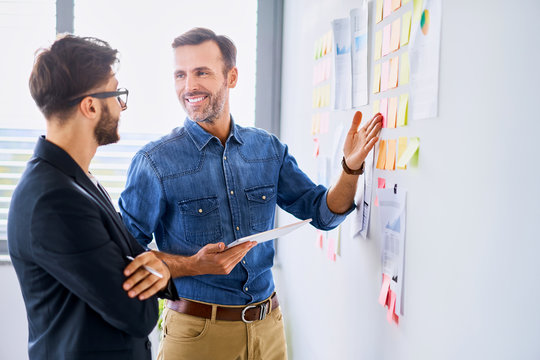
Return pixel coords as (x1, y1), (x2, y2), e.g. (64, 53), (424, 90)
(29, 35), (118, 118)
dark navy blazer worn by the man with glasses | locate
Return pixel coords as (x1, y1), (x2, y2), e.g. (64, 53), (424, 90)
(8, 137), (172, 360)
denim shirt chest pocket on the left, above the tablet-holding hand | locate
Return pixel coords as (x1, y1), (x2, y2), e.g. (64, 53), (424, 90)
(178, 196), (223, 246)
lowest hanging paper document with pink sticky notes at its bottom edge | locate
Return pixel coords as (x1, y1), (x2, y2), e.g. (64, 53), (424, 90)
(377, 186), (407, 316)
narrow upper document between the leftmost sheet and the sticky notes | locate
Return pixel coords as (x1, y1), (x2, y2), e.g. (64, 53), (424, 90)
(350, 0), (368, 107)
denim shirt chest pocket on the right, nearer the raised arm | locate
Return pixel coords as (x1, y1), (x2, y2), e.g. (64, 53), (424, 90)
(244, 185), (276, 231)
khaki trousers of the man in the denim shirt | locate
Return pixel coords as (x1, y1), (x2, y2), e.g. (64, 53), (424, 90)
(158, 298), (287, 360)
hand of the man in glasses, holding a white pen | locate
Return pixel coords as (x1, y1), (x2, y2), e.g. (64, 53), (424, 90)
(123, 251), (171, 300)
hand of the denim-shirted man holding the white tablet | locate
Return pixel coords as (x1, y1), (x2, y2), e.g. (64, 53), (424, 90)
(191, 241), (257, 275)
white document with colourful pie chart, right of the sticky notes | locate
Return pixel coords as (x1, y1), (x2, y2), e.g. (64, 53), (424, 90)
(409, 0), (442, 120)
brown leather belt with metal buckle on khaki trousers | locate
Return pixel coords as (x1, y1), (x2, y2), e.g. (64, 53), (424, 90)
(167, 293), (279, 323)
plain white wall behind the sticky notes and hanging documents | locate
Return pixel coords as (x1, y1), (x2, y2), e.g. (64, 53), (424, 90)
(274, 0), (540, 360)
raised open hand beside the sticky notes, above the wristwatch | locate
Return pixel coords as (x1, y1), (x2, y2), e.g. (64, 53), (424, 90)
(343, 111), (382, 170)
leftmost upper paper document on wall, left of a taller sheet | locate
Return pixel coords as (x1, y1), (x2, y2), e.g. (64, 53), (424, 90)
(332, 18), (352, 110)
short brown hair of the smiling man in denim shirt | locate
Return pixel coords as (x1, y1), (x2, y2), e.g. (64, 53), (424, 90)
(172, 28), (236, 75)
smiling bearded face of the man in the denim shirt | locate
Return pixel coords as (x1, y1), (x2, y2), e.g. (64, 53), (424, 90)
(174, 41), (237, 125)
